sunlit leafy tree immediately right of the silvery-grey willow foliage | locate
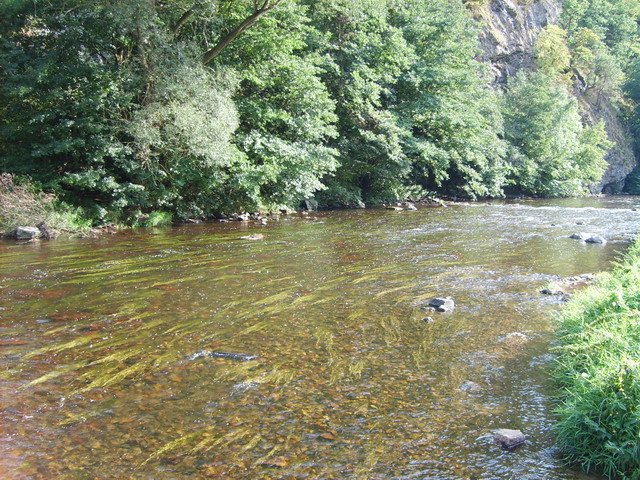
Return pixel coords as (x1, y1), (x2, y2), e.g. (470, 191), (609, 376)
(209, 2), (338, 208)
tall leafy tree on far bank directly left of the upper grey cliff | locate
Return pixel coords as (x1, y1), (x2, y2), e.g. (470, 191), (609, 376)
(397, 0), (506, 197)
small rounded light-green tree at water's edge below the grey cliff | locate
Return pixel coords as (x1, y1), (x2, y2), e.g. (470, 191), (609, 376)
(505, 71), (612, 196)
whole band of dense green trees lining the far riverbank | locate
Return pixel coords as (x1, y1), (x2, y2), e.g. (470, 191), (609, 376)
(0, 0), (640, 223)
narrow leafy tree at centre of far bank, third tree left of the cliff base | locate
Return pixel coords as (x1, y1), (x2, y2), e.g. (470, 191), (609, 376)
(309, 0), (412, 205)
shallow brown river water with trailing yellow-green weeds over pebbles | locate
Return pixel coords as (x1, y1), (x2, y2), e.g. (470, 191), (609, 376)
(0, 197), (640, 479)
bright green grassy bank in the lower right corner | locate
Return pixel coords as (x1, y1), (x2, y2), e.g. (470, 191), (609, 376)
(555, 241), (640, 479)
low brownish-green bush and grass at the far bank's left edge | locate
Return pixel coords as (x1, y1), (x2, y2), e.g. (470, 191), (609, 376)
(0, 173), (90, 235)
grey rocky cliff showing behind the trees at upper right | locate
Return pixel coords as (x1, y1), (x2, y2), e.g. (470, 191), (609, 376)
(477, 0), (637, 193)
